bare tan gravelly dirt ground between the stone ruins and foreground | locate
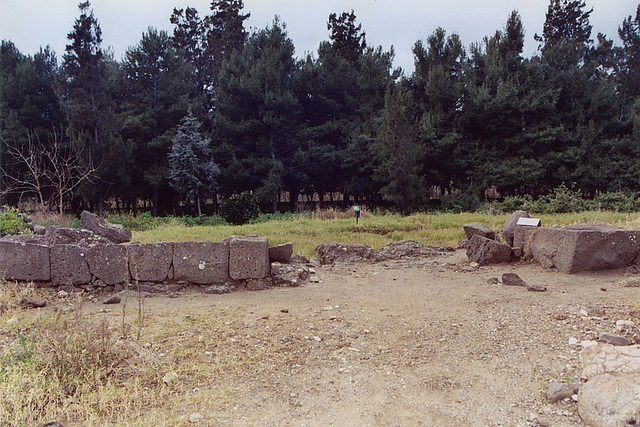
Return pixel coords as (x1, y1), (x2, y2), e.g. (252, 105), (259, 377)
(92, 251), (640, 426)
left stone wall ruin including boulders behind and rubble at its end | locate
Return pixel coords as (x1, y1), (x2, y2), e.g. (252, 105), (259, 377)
(0, 212), (308, 290)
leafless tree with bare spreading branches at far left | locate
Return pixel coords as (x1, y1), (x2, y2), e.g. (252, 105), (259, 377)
(0, 129), (98, 215)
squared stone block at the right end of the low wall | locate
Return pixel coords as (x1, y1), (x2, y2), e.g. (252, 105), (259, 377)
(229, 237), (270, 280)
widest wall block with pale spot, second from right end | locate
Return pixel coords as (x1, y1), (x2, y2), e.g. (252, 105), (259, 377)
(173, 242), (229, 284)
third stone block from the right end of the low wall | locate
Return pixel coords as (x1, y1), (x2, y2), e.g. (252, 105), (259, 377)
(127, 243), (174, 282)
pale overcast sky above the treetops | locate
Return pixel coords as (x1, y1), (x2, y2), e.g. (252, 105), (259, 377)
(0, 0), (638, 74)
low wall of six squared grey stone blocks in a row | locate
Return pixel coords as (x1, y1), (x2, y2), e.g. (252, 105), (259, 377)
(0, 236), (280, 287)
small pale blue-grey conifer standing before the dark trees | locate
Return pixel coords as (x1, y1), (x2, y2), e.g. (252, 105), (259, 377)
(169, 111), (220, 215)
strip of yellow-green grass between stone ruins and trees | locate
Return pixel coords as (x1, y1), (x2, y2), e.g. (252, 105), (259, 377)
(133, 211), (640, 257)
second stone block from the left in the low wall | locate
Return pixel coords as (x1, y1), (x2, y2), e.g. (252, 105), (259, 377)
(51, 245), (91, 286)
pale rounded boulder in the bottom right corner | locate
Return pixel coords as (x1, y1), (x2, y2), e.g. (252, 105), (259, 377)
(578, 374), (640, 427)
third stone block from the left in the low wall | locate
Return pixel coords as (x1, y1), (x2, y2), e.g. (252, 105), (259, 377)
(86, 244), (129, 286)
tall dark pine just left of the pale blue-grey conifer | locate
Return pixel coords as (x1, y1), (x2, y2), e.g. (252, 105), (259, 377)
(122, 28), (195, 215)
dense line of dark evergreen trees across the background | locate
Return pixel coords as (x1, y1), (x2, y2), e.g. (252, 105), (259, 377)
(0, 0), (640, 214)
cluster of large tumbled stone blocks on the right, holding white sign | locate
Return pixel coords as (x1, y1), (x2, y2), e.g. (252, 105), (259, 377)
(464, 211), (640, 274)
